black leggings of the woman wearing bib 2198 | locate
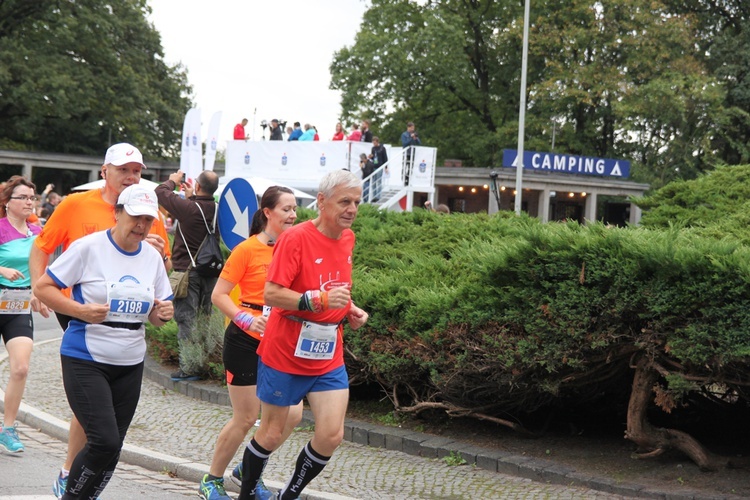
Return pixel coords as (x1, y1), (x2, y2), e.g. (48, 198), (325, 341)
(60, 356), (143, 500)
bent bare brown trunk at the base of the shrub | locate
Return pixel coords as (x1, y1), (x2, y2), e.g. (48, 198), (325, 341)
(625, 356), (726, 470)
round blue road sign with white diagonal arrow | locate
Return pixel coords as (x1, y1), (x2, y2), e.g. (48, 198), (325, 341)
(218, 177), (258, 250)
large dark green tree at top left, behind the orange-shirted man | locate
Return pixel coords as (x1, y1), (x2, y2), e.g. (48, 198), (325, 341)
(0, 0), (192, 158)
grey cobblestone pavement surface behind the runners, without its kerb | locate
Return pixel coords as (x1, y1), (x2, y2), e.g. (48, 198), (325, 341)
(0, 341), (627, 499)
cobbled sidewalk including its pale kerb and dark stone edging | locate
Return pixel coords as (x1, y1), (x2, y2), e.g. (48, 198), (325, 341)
(0, 339), (724, 499)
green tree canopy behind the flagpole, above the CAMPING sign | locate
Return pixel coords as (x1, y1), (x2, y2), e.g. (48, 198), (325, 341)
(330, 0), (750, 186)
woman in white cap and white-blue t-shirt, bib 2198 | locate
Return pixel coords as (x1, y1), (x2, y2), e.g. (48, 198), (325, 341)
(34, 184), (174, 498)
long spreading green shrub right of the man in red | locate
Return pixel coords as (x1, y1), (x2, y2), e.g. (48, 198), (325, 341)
(347, 207), (750, 422)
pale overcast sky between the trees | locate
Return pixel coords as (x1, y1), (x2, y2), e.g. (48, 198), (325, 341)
(149, 0), (367, 149)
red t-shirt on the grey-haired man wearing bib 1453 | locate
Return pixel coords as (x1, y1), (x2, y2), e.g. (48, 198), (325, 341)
(258, 221), (355, 375)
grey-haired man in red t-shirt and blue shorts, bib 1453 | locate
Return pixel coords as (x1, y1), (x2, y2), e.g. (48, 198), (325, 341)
(239, 170), (368, 500)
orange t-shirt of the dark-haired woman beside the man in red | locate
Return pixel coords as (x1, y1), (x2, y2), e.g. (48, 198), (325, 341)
(219, 235), (273, 340)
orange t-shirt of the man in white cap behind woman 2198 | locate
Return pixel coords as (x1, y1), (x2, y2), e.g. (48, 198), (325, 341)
(34, 189), (172, 256)
